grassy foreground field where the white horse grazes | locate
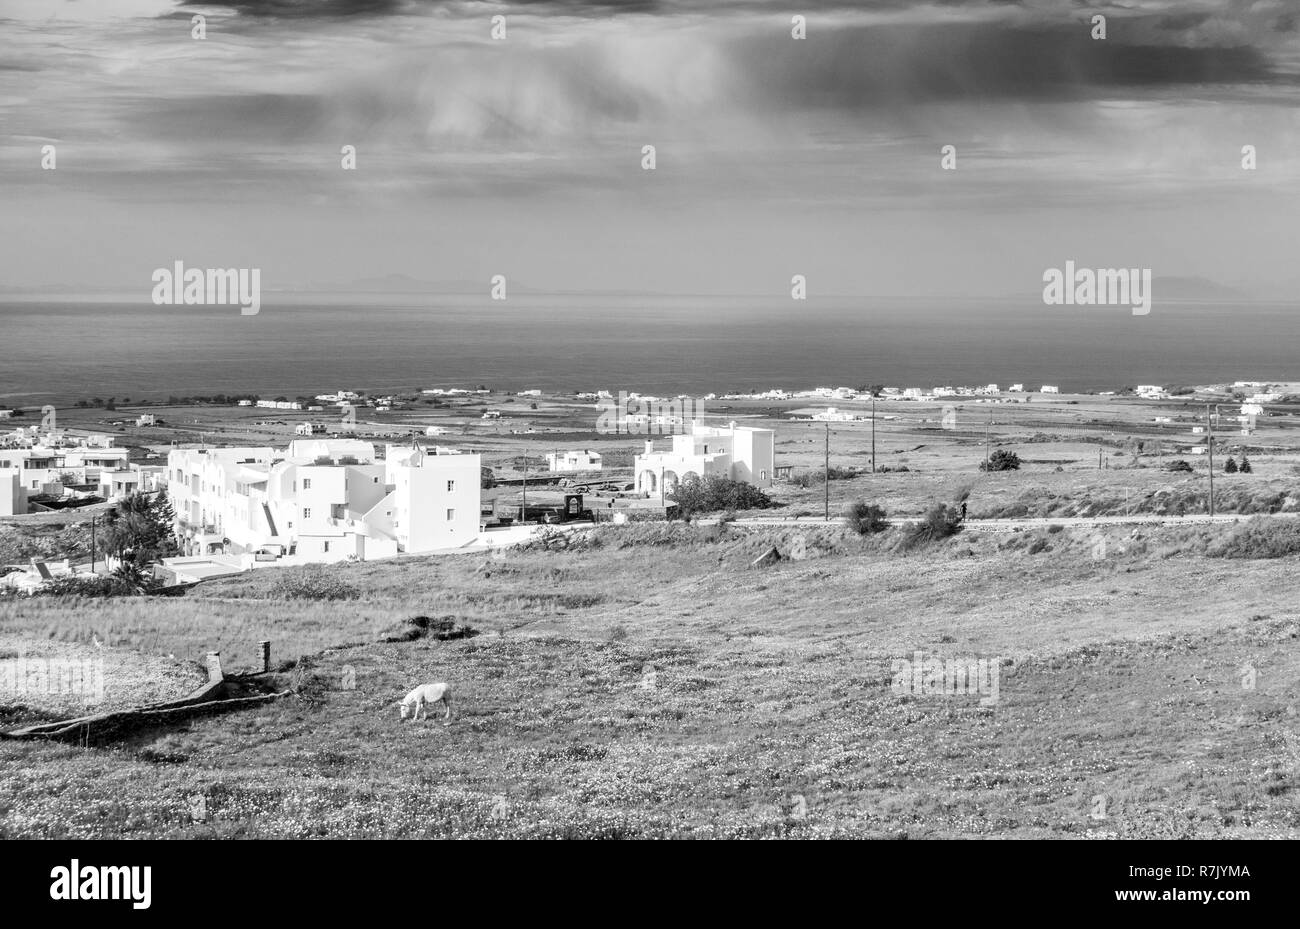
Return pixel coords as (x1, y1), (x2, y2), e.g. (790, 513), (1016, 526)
(0, 522), (1300, 838)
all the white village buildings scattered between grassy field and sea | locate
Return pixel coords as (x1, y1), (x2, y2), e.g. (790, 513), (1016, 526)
(0, 381), (1288, 589)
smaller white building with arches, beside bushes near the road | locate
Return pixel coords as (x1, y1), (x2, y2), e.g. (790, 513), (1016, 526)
(633, 422), (776, 494)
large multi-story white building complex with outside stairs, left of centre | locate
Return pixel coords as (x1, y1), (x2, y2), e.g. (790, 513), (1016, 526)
(168, 439), (480, 561)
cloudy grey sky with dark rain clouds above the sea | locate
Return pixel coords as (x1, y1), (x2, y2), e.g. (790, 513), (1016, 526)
(0, 0), (1300, 299)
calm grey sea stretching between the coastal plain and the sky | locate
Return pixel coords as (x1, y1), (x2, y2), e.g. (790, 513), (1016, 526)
(0, 295), (1300, 404)
